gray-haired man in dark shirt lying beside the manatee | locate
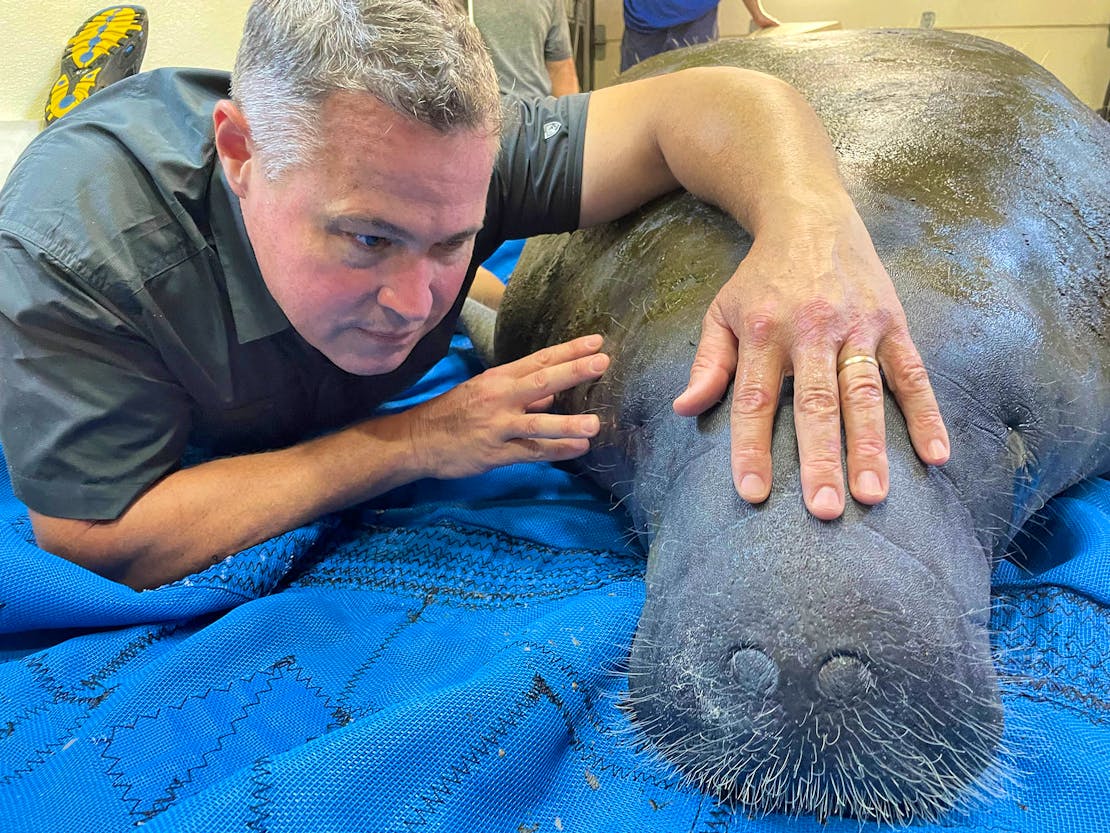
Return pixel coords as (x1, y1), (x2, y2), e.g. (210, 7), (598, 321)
(0, 0), (948, 588)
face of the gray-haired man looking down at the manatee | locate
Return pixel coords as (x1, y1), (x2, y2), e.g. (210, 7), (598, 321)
(240, 92), (497, 375)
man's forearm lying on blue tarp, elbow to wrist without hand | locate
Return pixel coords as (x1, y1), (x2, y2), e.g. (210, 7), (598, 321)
(32, 414), (428, 589)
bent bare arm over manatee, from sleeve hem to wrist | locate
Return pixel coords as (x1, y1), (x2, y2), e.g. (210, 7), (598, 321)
(583, 68), (850, 235)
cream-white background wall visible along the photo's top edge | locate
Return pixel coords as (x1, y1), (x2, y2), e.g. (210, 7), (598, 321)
(0, 0), (1110, 173)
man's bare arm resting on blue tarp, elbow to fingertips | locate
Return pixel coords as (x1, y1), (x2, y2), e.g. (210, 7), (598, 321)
(30, 335), (608, 589)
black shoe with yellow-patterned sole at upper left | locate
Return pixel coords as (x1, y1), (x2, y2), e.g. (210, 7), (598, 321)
(46, 6), (147, 124)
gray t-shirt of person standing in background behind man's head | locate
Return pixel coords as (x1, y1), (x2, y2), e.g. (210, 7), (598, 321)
(473, 0), (574, 99)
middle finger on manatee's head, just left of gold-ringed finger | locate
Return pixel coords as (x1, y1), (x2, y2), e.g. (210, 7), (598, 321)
(794, 348), (844, 521)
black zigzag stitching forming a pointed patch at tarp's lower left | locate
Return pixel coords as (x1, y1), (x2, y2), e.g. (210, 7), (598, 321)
(100, 656), (331, 821)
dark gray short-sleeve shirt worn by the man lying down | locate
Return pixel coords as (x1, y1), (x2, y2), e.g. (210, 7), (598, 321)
(0, 69), (588, 520)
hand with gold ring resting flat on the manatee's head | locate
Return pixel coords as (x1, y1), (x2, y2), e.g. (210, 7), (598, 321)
(674, 199), (949, 520)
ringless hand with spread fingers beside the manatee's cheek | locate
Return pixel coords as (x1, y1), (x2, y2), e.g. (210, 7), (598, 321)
(407, 335), (609, 479)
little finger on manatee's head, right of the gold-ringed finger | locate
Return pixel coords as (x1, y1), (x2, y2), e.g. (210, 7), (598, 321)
(881, 332), (951, 465)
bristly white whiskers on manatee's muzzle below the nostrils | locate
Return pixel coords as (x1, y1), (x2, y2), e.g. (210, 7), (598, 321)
(622, 595), (1003, 824)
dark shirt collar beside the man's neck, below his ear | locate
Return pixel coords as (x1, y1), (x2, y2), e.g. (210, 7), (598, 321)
(209, 160), (291, 344)
